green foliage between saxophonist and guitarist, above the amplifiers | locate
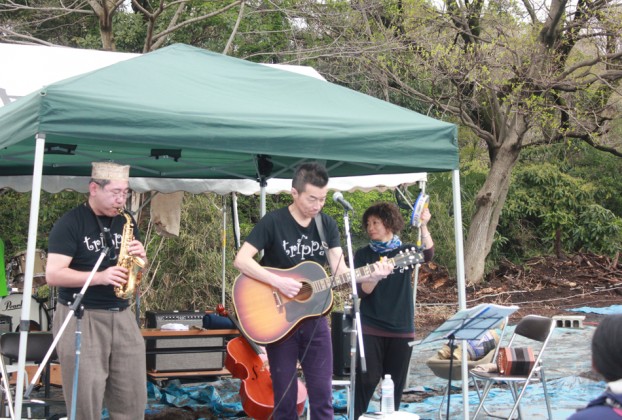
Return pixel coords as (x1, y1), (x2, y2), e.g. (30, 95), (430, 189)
(141, 194), (236, 311)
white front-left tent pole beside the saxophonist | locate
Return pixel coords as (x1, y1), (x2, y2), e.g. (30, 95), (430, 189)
(15, 134), (45, 419)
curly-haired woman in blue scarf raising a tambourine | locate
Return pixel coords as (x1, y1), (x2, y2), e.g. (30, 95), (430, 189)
(354, 202), (434, 419)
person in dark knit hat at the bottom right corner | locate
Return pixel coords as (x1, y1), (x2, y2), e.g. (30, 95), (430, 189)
(568, 314), (622, 420)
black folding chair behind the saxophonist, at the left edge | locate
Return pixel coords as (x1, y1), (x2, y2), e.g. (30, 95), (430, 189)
(0, 332), (60, 419)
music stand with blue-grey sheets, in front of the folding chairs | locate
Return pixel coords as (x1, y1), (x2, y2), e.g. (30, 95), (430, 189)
(420, 303), (518, 418)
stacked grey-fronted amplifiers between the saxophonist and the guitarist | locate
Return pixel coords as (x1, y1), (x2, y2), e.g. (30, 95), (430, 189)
(145, 311), (226, 372)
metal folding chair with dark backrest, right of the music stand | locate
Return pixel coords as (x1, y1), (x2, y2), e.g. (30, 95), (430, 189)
(469, 315), (556, 419)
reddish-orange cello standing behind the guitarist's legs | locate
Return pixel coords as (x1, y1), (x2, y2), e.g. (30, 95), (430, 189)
(225, 310), (307, 420)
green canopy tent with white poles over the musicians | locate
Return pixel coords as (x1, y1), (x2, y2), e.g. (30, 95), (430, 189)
(0, 45), (465, 415)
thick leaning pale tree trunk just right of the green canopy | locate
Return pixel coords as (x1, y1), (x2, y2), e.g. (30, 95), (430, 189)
(464, 130), (522, 284)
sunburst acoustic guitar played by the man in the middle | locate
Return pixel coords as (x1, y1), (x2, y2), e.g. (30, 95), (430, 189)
(232, 249), (424, 344)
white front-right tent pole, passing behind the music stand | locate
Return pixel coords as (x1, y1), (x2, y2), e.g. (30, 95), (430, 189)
(451, 169), (469, 419)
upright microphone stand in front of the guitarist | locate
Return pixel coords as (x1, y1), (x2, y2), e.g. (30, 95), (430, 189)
(343, 207), (367, 420)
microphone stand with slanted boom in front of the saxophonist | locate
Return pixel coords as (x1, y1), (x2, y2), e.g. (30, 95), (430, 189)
(24, 247), (109, 420)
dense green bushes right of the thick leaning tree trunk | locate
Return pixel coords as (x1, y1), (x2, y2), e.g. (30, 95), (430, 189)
(499, 163), (622, 257)
